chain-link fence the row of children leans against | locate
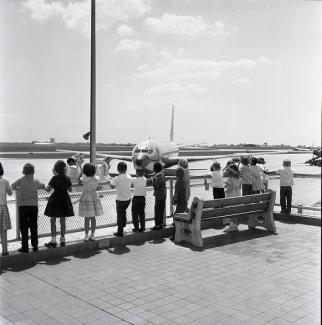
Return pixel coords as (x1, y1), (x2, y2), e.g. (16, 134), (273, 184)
(8, 175), (321, 240)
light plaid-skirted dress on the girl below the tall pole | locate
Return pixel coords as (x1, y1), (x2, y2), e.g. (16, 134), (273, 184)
(78, 176), (103, 217)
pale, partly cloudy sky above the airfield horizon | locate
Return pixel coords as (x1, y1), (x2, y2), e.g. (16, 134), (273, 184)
(0, 0), (322, 146)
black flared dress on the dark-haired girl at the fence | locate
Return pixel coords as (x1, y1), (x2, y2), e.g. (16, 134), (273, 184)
(44, 175), (74, 218)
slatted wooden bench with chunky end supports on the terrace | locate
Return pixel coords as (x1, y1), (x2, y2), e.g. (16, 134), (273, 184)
(174, 191), (276, 247)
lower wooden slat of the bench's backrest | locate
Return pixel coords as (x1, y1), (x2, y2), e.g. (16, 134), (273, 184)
(201, 201), (269, 220)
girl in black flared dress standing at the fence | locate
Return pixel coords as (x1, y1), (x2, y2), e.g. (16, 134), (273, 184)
(44, 160), (74, 248)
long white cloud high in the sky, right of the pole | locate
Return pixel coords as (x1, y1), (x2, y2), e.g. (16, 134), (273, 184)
(145, 14), (229, 37)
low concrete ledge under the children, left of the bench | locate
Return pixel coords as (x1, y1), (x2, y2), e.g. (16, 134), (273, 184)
(0, 226), (173, 270)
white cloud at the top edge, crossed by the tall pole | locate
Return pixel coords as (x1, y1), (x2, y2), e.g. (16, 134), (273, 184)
(22, 0), (151, 35)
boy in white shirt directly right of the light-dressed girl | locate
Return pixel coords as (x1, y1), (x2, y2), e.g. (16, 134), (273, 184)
(111, 161), (132, 237)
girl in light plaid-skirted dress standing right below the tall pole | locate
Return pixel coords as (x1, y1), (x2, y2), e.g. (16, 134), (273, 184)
(78, 163), (103, 241)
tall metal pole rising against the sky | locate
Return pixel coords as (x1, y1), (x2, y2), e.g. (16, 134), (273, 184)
(90, 0), (96, 164)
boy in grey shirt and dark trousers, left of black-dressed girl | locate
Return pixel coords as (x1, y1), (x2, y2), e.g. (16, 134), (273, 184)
(11, 164), (45, 253)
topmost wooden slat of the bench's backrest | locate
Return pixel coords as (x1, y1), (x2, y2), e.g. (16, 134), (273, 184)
(203, 192), (270, 209)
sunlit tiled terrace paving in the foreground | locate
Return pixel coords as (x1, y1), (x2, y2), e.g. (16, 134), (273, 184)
(0, 221), (321, 325)
